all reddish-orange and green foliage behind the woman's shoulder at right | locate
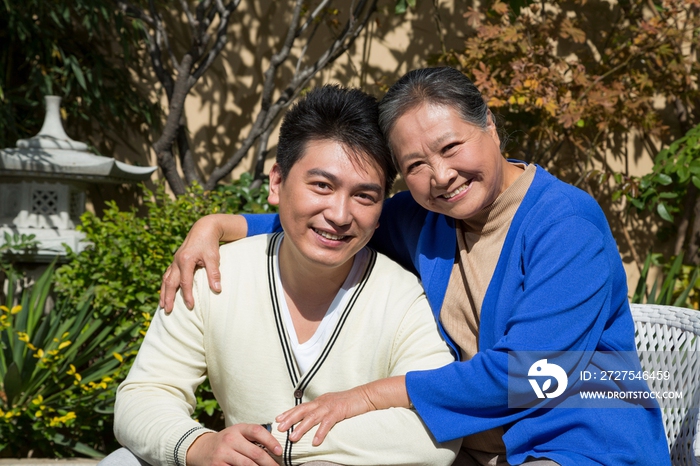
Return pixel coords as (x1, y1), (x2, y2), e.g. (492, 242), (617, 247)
(438, 0), (700, 278)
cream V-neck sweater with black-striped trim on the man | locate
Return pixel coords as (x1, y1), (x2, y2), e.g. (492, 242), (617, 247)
(115, 235), (459, 465)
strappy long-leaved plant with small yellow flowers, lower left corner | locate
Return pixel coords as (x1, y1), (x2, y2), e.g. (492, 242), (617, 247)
(0, 264), (139, 457)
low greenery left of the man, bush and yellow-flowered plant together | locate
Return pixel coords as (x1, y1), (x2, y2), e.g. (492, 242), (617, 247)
(0, 175), (271, 457)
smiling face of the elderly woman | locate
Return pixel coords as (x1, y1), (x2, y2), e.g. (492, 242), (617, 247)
(389, 103), (522, 219)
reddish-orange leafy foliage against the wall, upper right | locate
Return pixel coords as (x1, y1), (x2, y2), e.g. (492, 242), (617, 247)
(441, 0), (700, 191)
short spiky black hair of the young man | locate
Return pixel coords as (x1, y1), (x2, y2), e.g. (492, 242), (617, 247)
(277, 85), (396, 193)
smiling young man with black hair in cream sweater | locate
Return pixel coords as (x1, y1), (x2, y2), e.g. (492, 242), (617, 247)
(106, 86), (458, 466)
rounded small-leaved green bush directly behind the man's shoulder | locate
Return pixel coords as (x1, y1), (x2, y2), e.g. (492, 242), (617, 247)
(46, 174), (273, 456)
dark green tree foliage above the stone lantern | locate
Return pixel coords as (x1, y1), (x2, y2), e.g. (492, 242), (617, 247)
(0, 0), (160, 147)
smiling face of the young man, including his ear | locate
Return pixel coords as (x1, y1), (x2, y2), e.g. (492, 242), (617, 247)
(268, 140), (385, 273)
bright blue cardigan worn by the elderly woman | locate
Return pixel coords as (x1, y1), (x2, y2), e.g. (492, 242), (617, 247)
(246, 167), (670, 466)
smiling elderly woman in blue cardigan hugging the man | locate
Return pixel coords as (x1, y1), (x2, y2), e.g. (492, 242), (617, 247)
(161, 68), (670, 466)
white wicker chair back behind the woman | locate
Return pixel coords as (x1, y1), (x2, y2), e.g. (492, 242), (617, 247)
(631, 304), (700, 466)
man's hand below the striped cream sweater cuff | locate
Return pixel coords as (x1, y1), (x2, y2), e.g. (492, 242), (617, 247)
(187, 424), (282, 466)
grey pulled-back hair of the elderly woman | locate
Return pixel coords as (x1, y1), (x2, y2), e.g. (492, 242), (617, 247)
(379, 67), (495, 140)
